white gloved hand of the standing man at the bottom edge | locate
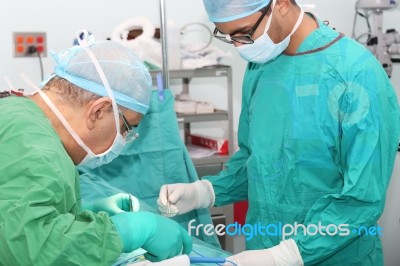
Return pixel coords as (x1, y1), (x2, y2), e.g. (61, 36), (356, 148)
(224, 239), (304, 266)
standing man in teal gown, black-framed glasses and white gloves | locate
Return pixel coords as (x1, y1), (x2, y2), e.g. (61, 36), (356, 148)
(158, 0), (400, 266)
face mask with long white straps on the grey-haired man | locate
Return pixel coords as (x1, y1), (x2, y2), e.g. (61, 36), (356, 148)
(22, 32), (126, 168)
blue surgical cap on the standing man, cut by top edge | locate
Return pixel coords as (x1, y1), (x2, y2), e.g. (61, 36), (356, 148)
(203, 0), (270, 22)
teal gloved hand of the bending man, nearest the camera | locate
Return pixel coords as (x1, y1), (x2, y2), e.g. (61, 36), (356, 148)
(110, 212), (192, 261)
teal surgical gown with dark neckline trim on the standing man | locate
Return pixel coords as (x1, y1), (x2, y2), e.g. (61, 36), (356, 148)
(205, 15), (400, 265)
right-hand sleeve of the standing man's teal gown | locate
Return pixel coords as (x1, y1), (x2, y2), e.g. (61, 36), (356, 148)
(294, 58), (400, 265)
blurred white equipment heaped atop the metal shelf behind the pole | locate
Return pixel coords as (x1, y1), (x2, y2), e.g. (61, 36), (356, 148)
(111, 17), (231, 70)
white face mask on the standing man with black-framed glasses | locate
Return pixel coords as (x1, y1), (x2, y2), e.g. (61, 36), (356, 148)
(236, 0), (304, 64)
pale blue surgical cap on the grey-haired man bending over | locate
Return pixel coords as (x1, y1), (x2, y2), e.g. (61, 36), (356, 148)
(42, 35), (152, 114)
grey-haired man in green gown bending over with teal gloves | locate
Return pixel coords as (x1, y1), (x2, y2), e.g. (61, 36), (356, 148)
(0, 31), (191, 266)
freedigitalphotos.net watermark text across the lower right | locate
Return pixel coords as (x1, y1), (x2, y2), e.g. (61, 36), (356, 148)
(188, 219), (383, 241)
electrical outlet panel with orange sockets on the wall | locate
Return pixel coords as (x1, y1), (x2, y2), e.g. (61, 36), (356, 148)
(13, 32), (47, 57)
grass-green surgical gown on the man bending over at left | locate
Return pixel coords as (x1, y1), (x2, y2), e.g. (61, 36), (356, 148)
(0, 96), (122, 266)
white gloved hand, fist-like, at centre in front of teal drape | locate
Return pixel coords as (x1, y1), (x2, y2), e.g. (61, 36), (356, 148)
(157, 180), (215, 217)
